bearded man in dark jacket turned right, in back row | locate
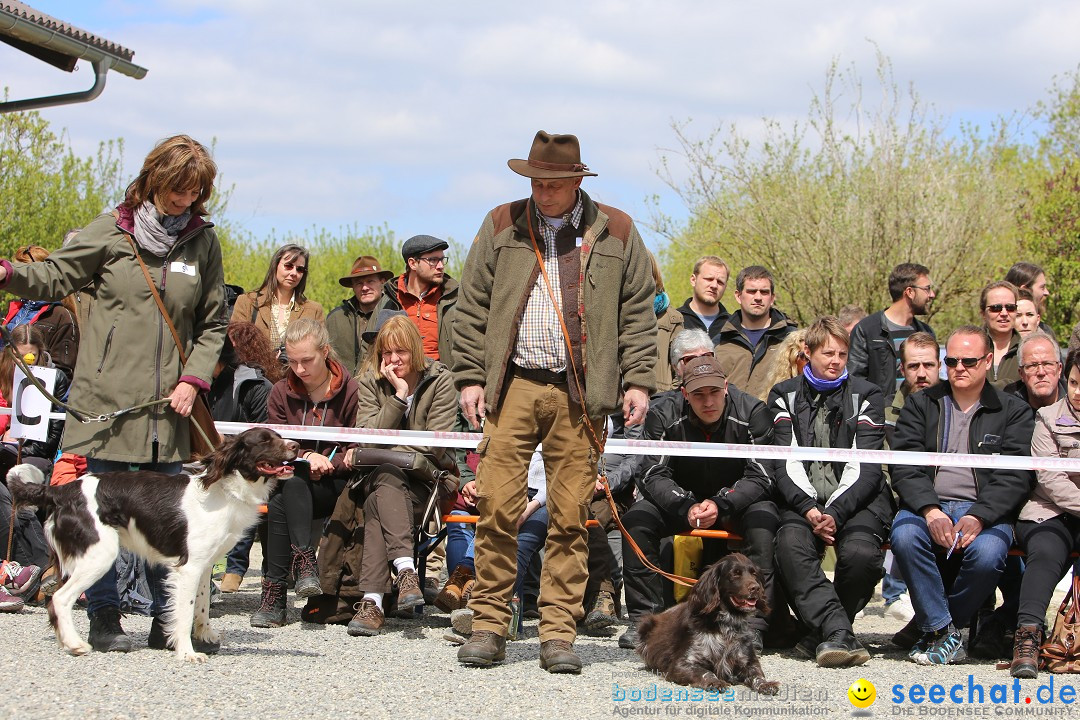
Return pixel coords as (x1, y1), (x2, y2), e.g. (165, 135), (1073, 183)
(848, 262), (937, 397)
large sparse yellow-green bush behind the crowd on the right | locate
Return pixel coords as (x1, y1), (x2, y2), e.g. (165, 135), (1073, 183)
(656, 54), (1017, 329)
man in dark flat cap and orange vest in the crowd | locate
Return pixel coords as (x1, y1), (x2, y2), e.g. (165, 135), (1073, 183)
(382, 235), (458, 367)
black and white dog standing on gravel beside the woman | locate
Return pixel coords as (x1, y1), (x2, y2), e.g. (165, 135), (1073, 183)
(8, 427), (298, 662)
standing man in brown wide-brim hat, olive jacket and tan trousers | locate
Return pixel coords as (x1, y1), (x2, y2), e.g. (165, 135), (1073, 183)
(454, 132), (657, 673)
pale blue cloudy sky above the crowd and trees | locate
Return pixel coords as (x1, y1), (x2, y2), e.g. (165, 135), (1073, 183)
(0, 0), (1080, 255)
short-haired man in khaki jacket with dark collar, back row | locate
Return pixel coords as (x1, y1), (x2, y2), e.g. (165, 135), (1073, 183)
(716, 266), (796, 400)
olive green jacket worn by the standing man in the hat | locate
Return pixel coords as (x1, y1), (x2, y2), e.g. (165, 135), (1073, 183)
(454, 191), (657, 418)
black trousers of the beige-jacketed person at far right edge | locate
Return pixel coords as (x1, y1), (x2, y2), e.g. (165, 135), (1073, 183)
(1016, 514), (1080, 627)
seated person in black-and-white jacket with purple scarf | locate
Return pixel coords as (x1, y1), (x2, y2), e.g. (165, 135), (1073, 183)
(769, 316), (894, 667)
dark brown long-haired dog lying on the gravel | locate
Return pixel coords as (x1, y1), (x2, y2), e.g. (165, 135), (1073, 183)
(637, 553), (780, 695)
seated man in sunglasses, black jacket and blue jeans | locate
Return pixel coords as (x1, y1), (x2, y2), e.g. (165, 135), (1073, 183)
(891, 325), (1035, 665)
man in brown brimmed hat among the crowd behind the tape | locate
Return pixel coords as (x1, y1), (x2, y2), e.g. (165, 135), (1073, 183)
(326, 255), (394, 375)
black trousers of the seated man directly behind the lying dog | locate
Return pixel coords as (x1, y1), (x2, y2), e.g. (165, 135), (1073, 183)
(622, 500), (780, 631)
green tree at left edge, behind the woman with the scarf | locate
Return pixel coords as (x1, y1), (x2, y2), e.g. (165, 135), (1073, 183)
(0, 105), (123, 257)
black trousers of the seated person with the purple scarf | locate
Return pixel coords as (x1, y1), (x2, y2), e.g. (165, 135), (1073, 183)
(777, 510), (888, 637)
